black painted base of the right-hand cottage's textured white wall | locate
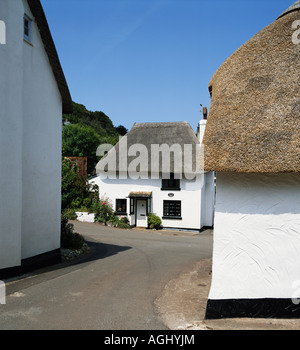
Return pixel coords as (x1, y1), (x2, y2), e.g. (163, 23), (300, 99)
(205, 298), (300, 320)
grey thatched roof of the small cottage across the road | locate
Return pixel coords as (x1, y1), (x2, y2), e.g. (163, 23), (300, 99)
(97, 121), (199, 174)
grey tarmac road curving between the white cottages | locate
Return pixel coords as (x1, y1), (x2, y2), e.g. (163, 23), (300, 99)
(0, 222), (213, 330)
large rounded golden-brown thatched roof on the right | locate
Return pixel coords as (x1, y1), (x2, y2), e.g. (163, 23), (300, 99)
(203, 1), (300, 173)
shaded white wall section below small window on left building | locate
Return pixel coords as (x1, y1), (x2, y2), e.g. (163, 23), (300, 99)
(22, 0), (62, 259)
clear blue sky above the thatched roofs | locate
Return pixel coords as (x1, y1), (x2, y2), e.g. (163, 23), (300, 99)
(41, 0), (293, 130)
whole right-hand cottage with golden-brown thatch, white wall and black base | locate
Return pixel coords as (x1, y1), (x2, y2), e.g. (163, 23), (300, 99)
(203, 1), (300, 318)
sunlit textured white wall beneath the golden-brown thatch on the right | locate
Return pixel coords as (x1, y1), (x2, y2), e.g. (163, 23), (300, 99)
(209, 173), (300, 299)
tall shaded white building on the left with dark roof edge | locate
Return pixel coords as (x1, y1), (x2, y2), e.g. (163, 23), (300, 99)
(0, 0), (72, 278)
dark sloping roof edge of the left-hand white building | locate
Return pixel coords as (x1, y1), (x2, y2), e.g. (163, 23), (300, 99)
(27, 0), (73, 114)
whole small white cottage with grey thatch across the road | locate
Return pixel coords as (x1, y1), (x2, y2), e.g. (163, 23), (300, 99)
(91, 120), (214, 230)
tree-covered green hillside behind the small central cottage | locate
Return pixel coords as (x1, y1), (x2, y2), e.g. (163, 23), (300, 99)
(62, 102), (127, 175)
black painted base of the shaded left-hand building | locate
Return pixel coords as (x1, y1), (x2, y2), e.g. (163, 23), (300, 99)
(0, 249), (61, 280)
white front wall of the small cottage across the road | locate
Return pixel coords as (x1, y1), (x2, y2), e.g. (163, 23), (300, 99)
(91, 175), (210, 230)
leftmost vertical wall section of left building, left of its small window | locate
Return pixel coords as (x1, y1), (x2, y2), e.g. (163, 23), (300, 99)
(0, 0), (23, 268)
